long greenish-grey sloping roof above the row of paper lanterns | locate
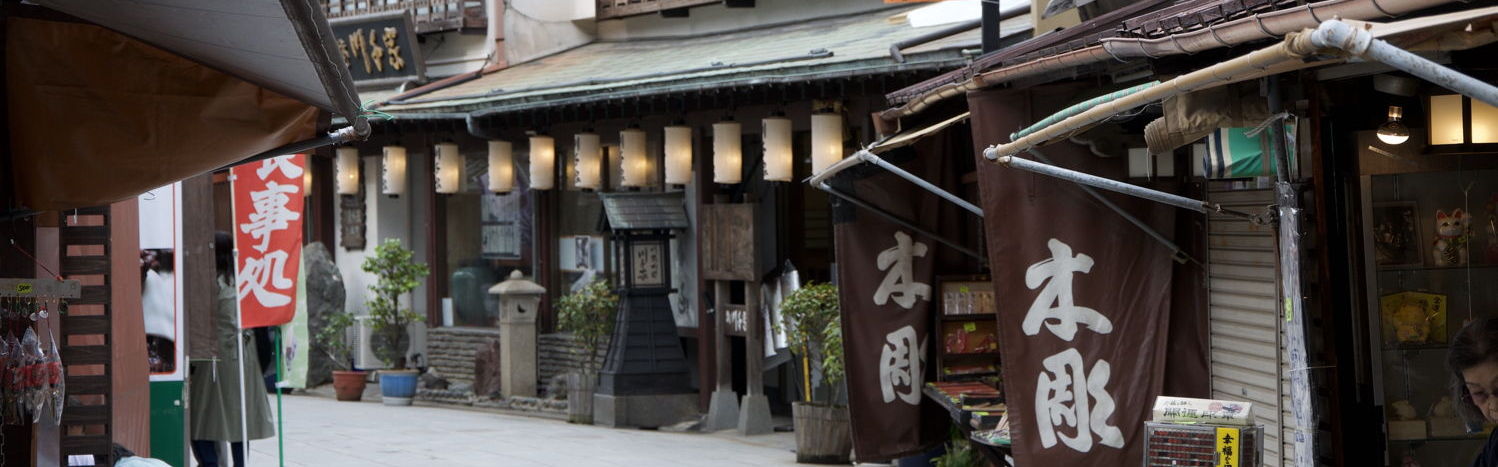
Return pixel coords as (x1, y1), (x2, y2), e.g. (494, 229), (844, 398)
(380, 7), (1029, 112)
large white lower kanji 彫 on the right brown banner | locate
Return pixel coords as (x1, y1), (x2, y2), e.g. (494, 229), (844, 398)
(1035, 349), (1124, 452)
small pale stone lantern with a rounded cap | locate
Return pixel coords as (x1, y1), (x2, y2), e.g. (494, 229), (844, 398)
(488, 269), (547, 397)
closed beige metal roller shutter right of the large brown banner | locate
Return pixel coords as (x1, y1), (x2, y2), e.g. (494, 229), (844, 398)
(1207, 181), (1293, 466)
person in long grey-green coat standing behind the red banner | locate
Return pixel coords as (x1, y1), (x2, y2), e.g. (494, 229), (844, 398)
(190, 232), (276, 467)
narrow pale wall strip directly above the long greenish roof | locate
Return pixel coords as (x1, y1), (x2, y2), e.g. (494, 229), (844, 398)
(593, 0), (890, 40)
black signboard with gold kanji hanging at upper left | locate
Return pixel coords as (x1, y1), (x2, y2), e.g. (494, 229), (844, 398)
(328, 10), (425, 84)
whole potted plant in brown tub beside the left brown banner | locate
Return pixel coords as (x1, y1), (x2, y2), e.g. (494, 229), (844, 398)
(774, 283), (852, 464)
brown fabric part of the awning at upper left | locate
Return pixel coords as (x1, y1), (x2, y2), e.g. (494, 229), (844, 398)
(4, 16), (319, 211)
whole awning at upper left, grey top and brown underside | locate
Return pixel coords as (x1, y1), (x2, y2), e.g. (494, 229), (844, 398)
(4, 0), (367, 211)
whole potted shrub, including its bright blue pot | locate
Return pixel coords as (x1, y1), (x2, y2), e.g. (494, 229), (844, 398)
(364, 238), (428, 406)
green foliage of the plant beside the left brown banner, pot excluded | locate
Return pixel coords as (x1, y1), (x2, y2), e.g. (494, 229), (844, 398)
(774, 283), (846, 403)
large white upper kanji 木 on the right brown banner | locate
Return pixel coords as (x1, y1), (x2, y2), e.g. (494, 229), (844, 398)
(1020, 238), (1113, 341)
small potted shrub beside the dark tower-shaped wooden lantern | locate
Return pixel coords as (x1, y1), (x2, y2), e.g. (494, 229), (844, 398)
(557, 280), (619, 424)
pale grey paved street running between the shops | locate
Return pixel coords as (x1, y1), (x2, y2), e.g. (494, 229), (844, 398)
(249, 395), (795, 467)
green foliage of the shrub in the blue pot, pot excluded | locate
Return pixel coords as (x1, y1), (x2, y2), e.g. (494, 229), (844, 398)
(364, 238), (428, 370)
